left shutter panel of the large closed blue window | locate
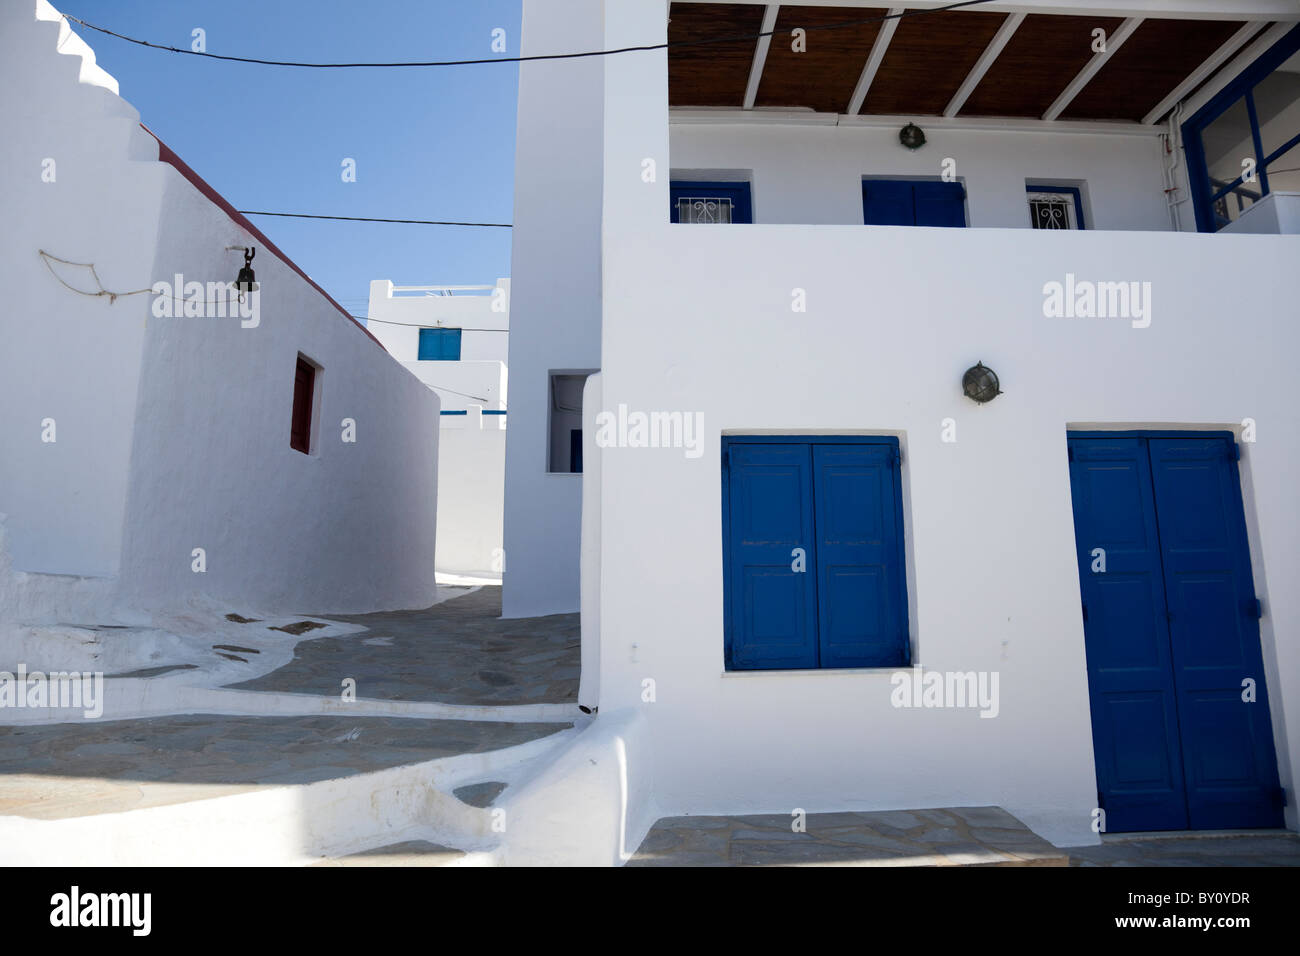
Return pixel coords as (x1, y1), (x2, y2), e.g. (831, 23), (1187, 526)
(727, 444), (818, 670)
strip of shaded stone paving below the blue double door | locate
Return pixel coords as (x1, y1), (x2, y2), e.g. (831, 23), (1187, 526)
(1069, 831), (1300, 866)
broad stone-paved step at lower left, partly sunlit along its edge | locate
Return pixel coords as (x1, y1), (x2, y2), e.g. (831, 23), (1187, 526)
(0, 714), (572, 819)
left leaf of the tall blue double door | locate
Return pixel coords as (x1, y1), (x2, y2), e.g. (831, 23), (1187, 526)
(1069, 438), (1187, 831)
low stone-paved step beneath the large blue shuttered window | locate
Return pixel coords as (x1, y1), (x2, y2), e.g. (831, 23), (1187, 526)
(628, 806), (1066, 866)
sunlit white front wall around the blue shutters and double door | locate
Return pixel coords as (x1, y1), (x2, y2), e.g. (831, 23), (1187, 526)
(593, 0), (1300, 843)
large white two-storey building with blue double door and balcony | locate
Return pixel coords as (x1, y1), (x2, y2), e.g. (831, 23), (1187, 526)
(506, 0), (1300, 862)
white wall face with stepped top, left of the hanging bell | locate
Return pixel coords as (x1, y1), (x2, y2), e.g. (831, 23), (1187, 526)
(0, 0), (164, 576)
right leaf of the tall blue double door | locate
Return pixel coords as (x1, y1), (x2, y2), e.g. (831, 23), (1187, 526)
(1149, 437), (1282, 830)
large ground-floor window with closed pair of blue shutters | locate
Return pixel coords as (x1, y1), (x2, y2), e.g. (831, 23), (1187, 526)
(722, 434), (911, 670)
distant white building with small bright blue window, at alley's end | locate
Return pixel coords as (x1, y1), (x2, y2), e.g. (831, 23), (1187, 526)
(367, 278), (510, 579)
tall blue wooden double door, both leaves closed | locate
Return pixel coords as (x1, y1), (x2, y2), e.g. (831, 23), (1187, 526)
(1069, 436), (1281, 832)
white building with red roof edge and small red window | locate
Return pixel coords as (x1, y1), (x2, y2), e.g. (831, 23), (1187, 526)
(0, 0), (438, 622)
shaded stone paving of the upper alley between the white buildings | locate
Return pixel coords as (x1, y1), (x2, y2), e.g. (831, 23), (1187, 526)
(231, 587), (580, 705)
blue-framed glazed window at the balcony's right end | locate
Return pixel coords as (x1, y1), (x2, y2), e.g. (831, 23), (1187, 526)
(1183, 26), (1300, 233)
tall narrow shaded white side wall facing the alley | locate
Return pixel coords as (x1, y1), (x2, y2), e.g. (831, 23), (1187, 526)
(502, 0), (605, 617)
